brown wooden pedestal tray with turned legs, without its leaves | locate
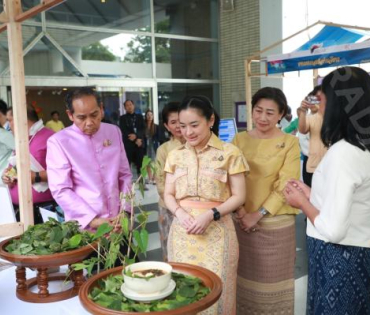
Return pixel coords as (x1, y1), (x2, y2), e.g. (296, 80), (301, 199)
(0, 236), (94, 303)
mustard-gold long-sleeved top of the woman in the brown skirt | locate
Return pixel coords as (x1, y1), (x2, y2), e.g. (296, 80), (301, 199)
(232, 132), (300, 215)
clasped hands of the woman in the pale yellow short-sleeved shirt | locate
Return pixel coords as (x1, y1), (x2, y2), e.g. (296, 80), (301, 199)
(176, 208), (213, 235)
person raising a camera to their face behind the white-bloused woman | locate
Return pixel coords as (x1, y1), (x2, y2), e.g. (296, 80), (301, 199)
(298, 85), (327, 187)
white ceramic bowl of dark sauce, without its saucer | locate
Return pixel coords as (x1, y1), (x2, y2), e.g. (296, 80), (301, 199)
(123, 261), (172, 294)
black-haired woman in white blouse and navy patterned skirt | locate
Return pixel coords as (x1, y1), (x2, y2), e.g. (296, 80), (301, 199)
(284, 67), (370, 314)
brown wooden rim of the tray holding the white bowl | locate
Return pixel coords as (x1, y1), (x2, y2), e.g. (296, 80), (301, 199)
(78, 262), (222, 315)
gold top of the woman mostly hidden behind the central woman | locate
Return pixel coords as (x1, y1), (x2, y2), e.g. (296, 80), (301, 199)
(155, 137), (181, 207)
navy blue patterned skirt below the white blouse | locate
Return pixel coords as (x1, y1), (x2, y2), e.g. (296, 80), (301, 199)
(307, 236), (370, 315)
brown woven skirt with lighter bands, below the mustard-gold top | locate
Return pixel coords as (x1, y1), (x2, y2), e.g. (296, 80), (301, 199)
(235, 215), (296, 315)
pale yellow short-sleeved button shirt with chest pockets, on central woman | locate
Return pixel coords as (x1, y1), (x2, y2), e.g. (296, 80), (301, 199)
(164, 134), (249, 202)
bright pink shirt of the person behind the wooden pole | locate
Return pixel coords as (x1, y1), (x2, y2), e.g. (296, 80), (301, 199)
(10, 128), (54, 205)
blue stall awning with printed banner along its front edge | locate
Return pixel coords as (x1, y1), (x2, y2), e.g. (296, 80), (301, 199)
(267, 26), (370, 74)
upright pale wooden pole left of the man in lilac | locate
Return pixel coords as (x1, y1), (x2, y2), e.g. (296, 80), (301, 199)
(5, 0), (34, 229)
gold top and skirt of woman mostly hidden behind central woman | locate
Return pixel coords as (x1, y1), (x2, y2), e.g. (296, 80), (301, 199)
(155, 137), (181, 261)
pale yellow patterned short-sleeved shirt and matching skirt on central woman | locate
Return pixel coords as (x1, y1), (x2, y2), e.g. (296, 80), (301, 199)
(165, 134), (248, 315)
